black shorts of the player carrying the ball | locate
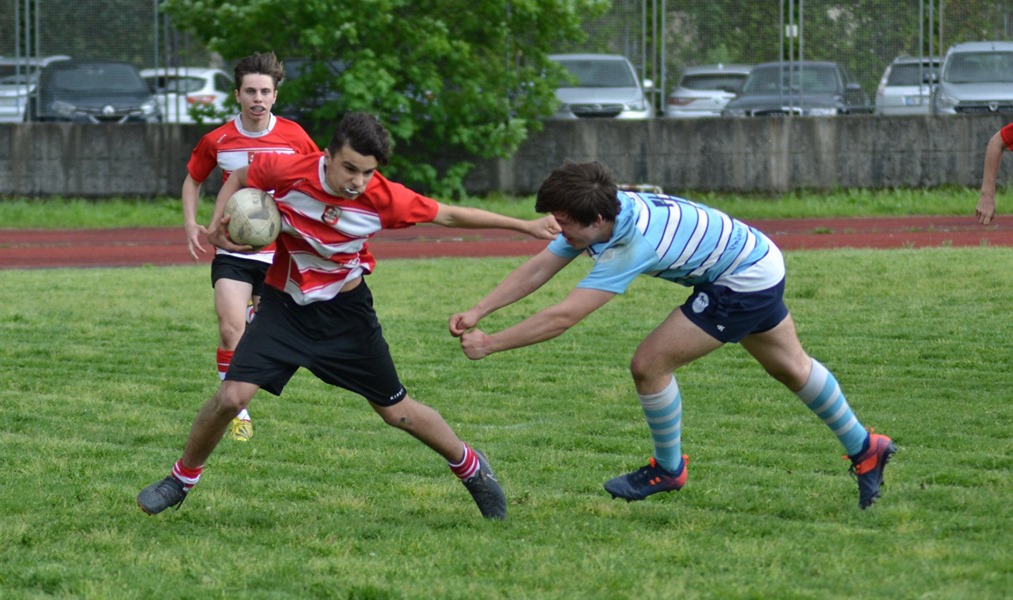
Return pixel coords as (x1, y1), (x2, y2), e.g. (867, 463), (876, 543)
(226, 281), (407, 406)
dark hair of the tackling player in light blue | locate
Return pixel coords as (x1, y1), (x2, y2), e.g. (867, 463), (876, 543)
(535, 160), (619, 226)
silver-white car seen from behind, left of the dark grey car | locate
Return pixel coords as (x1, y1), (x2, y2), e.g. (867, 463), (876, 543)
(665, 64), (753, 119)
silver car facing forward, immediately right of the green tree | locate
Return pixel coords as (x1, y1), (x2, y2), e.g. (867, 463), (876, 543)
(548, 54), (654, 119)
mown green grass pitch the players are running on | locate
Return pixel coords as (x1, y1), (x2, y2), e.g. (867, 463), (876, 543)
(0, 247), (1013, 600)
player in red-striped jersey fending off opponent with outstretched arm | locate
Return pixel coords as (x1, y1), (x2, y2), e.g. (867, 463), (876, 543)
(137, 113), (559, 519)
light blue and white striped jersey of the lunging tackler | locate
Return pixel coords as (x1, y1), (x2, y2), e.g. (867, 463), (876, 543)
(549, 192), (783, 294)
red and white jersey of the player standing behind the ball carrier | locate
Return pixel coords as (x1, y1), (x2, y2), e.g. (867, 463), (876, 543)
(186, 115), (320, 263)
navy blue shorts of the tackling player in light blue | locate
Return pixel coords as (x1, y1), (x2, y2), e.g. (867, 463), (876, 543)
(680, 279), (788, 344)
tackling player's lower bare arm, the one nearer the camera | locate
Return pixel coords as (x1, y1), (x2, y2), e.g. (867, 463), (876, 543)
(461, 288), (615, 361)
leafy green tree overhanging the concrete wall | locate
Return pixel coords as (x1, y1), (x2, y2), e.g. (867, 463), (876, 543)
(162, 0), (609, 195)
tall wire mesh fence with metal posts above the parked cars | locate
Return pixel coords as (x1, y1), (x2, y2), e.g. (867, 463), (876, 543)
(0, 0), (1013, 117)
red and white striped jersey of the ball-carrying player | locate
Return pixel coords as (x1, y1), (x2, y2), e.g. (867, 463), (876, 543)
(246, 152), (440, 304)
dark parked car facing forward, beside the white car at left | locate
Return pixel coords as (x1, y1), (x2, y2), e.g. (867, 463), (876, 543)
(28, 60), (162, 123)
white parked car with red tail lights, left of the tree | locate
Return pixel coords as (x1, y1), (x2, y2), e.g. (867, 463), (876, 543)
(141, 67), (231, 123)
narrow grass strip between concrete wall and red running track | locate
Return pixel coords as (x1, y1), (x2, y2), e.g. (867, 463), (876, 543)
(0, 188), (978, 229)
